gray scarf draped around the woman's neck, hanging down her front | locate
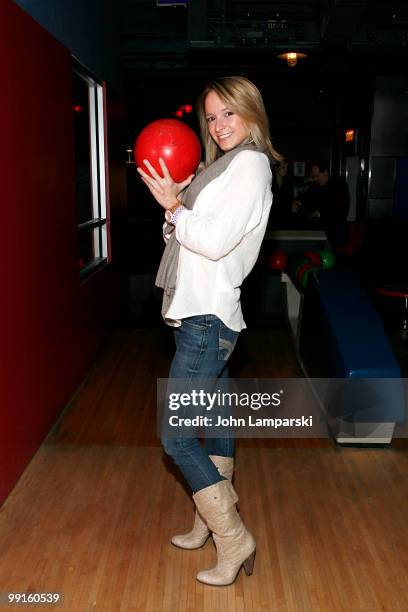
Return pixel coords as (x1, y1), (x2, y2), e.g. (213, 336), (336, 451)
(156, 144), (262, 318)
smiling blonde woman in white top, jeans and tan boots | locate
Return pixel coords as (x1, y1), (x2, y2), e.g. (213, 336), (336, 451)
(138, 77), (281, 585)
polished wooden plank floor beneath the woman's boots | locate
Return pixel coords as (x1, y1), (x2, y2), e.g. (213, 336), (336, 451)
(0, 329), (408, 612)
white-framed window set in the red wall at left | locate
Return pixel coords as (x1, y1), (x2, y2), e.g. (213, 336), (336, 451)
(72, 62), (109, 279)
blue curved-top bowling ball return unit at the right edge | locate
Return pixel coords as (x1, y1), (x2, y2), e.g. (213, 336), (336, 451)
(298, 269), (405, 436)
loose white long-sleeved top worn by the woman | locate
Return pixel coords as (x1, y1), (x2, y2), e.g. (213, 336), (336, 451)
(166, 150), (272, 331)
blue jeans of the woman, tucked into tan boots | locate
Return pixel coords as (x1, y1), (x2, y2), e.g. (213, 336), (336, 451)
(162, 315), (239, 493)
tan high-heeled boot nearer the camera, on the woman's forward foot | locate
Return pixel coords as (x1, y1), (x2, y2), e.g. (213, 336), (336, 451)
(193, 480), (256, 586)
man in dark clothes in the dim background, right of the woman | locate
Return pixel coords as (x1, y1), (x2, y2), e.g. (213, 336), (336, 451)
(292, 160), (350, 250)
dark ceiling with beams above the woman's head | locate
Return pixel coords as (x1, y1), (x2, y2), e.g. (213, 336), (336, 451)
(120, 0), (408, 88)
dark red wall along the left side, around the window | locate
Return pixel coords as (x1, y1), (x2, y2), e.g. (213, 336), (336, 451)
(0, 0), (121, 503)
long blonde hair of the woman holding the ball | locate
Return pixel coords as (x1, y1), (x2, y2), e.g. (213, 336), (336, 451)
(197, 76), (283, 165)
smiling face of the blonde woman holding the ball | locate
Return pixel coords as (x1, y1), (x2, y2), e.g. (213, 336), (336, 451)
(204, 91), (250, 151)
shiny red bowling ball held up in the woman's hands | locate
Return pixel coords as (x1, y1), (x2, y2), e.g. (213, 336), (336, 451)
(134, 119), (201, 183)
